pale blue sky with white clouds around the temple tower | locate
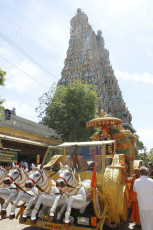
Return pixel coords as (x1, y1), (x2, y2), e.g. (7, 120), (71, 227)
(0, 0), (153, 151)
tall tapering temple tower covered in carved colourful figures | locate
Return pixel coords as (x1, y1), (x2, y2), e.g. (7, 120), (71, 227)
(58, 9), (135, 133)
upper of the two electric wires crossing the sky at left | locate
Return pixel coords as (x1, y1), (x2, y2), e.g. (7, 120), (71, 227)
(0, 32), (58, 79)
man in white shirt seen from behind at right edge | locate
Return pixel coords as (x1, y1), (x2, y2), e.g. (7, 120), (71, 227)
(133, 167), (153, 230)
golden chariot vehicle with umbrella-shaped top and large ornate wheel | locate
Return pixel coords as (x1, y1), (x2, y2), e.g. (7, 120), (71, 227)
(19, 112), (142, 230)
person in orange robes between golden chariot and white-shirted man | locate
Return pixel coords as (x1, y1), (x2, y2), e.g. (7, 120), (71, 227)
(127, 169), (141, 226)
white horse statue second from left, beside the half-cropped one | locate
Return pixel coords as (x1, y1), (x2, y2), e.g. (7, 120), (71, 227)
(4, 163), (38, 219)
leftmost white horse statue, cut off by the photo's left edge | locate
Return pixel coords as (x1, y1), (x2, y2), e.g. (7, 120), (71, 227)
(0, 166), (18, 218)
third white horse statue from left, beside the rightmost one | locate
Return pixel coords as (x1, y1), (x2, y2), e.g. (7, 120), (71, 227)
(25, 165), (66, 224)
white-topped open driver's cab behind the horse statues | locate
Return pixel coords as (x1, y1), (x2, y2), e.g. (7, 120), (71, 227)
(44, 140), (115, 172)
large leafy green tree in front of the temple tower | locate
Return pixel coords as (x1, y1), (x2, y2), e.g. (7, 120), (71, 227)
(36, 81), (97, 141)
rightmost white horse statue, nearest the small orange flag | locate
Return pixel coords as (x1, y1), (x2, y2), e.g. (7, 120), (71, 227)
(51, 162), (100, 227)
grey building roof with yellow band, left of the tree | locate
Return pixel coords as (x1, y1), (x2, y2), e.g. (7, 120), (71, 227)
(0, 110), (61, 147)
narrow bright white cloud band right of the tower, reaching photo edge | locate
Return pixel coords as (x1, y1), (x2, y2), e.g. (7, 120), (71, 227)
(114, 70), (153, 84)
